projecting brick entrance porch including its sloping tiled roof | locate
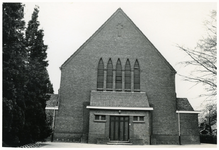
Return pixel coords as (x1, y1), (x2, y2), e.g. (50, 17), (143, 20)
(86, 91), (153, 145)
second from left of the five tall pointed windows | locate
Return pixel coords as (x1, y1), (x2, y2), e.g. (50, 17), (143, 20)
(106, 58), (113, 90)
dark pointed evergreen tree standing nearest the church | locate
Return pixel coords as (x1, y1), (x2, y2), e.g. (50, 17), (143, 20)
(25, 7), (53, 142)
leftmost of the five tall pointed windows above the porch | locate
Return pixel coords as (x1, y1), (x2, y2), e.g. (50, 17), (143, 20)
(97, 58), (104, 89)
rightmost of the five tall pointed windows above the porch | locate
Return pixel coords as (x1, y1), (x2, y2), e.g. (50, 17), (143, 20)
(134, 59), (140, 91)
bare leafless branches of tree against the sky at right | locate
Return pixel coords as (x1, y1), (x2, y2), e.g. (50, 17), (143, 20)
(177, 10), (217, 101)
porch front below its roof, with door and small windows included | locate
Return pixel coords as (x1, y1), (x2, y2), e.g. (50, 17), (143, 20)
(87, 107), (151, 145)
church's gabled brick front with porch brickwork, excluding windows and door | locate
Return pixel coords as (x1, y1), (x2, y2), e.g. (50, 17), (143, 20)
(54, 9), (198, 144)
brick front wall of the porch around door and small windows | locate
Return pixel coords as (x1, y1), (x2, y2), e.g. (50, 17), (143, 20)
(88, 109), (151, 144)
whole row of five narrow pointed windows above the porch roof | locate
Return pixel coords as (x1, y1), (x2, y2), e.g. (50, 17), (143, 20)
(97, 58), (140, 92)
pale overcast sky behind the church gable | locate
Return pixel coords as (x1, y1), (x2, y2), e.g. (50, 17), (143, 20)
(25, 2), (217, 108)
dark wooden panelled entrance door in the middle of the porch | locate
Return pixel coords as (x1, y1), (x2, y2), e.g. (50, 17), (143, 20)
(109, 116), (129, 141)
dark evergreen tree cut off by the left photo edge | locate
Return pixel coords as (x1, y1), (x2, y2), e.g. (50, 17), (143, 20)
(3, 3), (27, 146)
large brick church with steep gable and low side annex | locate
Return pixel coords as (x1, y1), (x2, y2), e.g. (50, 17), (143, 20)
(53, 8), (200, 145)
